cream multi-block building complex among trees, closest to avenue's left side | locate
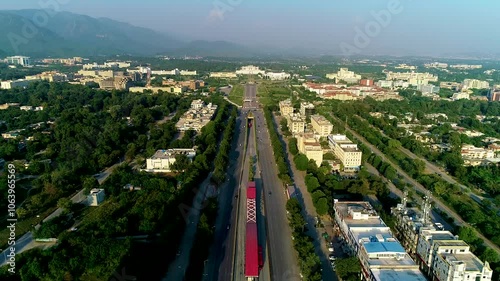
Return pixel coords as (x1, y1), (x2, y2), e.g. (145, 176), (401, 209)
(175, 100), (217, 132)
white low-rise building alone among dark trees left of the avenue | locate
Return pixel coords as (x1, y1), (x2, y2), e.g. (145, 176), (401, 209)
(145, 148), (196, 173)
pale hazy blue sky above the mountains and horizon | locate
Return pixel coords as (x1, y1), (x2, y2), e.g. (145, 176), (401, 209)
(0, 0), (500, 55)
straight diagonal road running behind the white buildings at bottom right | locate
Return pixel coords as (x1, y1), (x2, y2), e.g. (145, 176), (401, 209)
(329, 113), (500, 253)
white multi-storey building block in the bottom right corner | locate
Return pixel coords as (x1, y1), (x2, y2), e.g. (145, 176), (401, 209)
(417, 230), (493, 281)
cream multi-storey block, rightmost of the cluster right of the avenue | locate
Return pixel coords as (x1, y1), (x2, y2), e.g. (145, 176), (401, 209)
(328, 135), (363, 171)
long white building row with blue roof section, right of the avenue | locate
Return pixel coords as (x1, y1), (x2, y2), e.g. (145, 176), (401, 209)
(334, 199), (426, 281)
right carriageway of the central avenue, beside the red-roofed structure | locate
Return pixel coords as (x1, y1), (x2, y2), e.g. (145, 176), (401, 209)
(252, 84), (301, 281)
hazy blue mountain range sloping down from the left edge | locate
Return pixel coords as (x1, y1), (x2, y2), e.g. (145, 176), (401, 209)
(0, 10), (258, 57)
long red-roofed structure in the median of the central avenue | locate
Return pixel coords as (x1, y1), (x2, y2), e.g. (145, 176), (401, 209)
(245, 182), (259, 278)
